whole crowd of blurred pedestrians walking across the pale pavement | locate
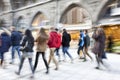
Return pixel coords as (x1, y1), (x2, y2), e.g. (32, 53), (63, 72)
(0, 26), (107, 77)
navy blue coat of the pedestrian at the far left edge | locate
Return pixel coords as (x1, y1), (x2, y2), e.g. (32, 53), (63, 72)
(0, 32), (11, 53)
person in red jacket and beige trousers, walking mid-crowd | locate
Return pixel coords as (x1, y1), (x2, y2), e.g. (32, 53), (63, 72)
(48, 27), (58, 70)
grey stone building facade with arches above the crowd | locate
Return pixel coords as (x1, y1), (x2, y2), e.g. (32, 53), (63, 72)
(0, 0), (115, 27)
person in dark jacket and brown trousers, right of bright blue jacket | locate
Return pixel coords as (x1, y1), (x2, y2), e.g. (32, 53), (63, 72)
(84, 30), (92, 61)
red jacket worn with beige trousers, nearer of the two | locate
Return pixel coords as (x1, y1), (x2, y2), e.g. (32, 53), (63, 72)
(48, 31), (58, 48)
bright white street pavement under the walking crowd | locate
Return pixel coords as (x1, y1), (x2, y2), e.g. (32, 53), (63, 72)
(0, 48), (120, 80)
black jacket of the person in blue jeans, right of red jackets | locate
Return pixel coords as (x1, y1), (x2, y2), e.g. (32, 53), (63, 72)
(62, 32), (71, 47)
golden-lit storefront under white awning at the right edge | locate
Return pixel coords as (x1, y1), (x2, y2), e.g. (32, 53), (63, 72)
(97, 19), (120, 53)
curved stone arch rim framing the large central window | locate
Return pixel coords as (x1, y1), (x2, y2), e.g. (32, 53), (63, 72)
(59, 3), (92, 23)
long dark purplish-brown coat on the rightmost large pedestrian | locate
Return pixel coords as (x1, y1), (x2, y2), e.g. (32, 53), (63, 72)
(92, 33), (105, 57)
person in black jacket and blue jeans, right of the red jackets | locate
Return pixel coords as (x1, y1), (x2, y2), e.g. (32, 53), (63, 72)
(62, 29), (73, 62)
